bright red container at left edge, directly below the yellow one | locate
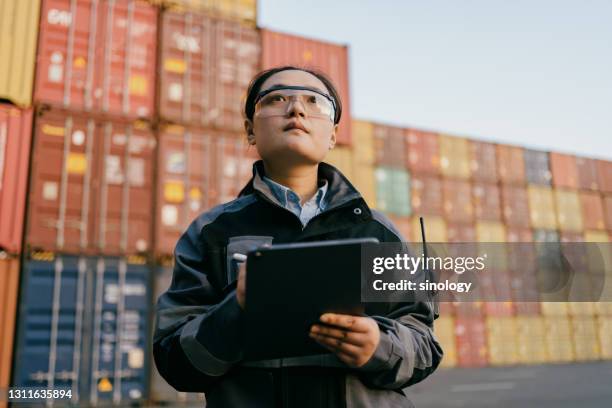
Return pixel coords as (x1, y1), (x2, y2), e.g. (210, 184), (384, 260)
(0, 104), (32, 254)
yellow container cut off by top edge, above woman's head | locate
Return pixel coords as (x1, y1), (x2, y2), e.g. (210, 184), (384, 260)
(149, 0), (257, 27)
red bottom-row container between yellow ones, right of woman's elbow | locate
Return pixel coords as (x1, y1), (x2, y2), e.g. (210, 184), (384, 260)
(455, 317), (488, 367)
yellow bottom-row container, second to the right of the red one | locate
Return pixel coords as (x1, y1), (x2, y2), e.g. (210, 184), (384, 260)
(515, 316), (547, 364)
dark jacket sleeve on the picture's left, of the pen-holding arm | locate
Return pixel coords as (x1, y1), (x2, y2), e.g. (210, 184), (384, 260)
(153, 220), (244, 392)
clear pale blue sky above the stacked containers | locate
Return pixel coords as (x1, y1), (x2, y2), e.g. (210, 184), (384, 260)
(258, 0), (612, 159)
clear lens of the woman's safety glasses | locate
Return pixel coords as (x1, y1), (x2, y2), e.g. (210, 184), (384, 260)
(255, 89), (334, 121)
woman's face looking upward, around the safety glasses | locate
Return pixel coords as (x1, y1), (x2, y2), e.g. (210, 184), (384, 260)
(246, 70), (337, 166)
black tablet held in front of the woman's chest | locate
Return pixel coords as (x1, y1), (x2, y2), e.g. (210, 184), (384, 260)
(245, 238), (378, 360)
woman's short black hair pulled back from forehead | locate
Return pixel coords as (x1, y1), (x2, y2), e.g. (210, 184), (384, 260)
(244, 65), (342, 124)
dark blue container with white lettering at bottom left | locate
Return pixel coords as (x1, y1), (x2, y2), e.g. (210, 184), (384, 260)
(13, 255), (151, 406)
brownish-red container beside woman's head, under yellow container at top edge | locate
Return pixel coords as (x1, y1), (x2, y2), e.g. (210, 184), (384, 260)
(159, 11), (260, 131)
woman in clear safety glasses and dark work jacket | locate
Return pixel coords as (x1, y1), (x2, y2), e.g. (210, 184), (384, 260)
(153, 66), (442, 408)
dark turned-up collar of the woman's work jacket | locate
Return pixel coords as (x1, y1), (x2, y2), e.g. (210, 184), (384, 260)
(238, 160), (369, 211)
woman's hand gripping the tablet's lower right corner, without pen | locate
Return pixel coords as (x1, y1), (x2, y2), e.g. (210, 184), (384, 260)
(310, 313), (380, 368)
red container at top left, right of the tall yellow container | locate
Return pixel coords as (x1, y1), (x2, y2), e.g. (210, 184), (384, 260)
(34, 0), (157, 118)
